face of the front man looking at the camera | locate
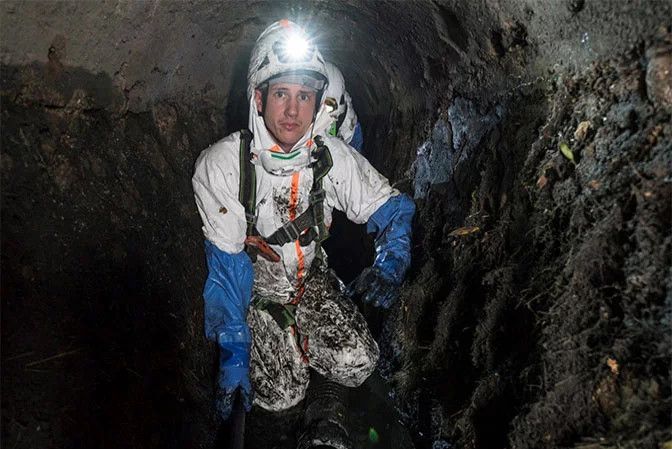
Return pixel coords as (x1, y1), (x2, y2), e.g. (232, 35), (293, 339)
(254, 83), (316, 152)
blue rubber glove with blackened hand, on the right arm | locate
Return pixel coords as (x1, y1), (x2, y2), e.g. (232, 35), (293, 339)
(348, 194), (415, 309)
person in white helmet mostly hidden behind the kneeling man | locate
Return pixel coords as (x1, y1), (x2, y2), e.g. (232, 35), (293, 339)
(315, 62), (364, 153)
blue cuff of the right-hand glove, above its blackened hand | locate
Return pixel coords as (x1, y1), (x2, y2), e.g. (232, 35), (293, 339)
(366, 194), (415, 285)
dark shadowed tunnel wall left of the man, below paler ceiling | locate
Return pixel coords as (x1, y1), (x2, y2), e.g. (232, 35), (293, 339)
(2, 64), (225, 447)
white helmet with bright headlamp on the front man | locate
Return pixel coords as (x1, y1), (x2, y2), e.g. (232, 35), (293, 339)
(247, 19), (328, 101)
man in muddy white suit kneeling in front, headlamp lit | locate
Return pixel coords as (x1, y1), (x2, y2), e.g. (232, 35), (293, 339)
(193, 20), (415, 430)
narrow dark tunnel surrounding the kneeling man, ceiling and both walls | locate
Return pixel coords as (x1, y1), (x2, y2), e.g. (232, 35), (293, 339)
(0, 0), (672, 449)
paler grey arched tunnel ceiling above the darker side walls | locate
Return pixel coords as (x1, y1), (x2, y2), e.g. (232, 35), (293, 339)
(1, 0), (669, 170)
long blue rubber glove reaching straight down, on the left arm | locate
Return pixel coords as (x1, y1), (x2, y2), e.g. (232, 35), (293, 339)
(203, 241), (254, 419)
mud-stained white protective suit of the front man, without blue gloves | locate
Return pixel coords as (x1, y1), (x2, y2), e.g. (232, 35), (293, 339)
(193, 19), (399, 410)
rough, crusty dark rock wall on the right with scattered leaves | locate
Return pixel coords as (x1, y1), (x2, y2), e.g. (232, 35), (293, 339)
(394, 44), (672, 448)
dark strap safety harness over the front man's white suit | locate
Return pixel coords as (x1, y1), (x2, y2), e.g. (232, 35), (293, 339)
(238, 129), (333, 330)
